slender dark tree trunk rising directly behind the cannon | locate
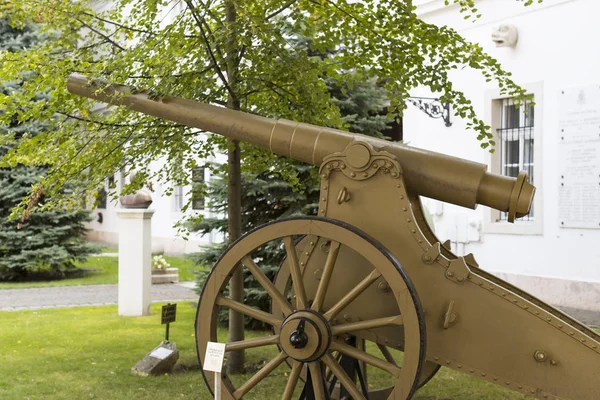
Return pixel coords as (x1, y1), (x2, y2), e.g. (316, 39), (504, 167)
(225, 1), (244, 374)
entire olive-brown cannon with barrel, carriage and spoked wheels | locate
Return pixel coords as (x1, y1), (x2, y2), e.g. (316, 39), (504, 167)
(68, 75), (600, 400)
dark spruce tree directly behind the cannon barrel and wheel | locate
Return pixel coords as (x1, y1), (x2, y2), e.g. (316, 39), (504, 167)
(189, 71), (392, 329)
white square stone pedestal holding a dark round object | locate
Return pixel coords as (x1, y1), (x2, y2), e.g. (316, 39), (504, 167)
(117, 208), (154, 316)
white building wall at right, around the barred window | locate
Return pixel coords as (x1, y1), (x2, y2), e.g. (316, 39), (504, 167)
(404, 0), (600, 311)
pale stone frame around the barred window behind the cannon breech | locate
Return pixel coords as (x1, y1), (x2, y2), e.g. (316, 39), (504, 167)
(483, 82), (544, 235)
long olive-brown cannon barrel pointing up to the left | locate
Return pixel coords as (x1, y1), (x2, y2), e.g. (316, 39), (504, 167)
(68, 74), (535, 220)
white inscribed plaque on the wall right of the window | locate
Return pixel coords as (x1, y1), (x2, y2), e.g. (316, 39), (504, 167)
(558, 85), (600, 229)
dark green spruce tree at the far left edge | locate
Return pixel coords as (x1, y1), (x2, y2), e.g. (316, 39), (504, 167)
(0, 19), (94, 280)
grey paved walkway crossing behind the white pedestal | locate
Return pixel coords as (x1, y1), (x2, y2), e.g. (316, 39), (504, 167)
(0, 282), (198, 311)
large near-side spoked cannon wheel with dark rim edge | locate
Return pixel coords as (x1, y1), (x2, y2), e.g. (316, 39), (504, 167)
(196, 217), (426, 400)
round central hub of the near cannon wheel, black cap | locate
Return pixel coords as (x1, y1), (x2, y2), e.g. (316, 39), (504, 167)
(279, 310), (331, 362)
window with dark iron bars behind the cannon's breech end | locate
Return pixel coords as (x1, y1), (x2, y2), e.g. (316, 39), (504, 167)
(496, 98), (535, 221)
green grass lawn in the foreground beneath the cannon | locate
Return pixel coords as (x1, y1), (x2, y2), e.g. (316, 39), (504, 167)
(0, 302), (564, 400)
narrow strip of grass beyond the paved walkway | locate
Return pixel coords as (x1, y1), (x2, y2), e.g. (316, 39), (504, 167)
(0, 255), (201, 289)
